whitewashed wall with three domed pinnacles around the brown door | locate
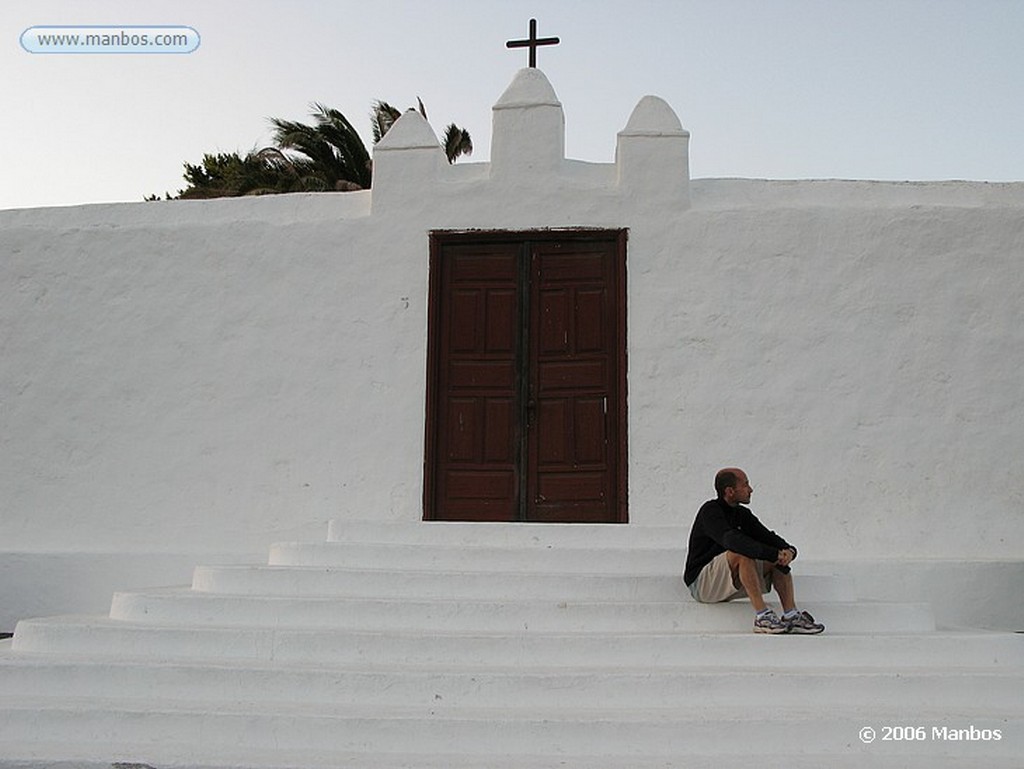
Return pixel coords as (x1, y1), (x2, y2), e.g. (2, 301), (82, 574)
(0, 71), (1024, 630)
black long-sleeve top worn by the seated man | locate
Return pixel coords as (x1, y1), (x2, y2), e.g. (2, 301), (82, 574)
(683, 500), (796, 586)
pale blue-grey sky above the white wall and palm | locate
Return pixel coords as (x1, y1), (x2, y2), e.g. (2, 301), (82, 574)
(0, 0), (1024, 209)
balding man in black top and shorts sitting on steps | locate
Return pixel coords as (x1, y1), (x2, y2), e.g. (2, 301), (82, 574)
(683, 468), (825, 634)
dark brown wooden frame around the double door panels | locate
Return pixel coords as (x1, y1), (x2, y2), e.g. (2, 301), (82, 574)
(423, 227), (629, 523)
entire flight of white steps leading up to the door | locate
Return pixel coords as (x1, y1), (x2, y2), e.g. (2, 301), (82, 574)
(0, 521), (1024, 769)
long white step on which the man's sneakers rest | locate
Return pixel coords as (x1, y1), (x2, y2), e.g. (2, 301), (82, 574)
(13, 616), (1011, 670)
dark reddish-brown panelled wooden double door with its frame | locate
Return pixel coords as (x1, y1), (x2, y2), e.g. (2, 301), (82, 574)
(424, 230), (627, 523)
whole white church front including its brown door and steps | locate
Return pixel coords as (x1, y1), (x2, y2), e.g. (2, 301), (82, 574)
(0, 68), (1024, 769)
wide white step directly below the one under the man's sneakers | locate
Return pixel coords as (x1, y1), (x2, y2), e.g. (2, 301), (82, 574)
(0, 654), (1024, 716)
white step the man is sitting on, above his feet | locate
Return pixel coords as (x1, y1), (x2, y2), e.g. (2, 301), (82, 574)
(110, 583), (935, 634)
